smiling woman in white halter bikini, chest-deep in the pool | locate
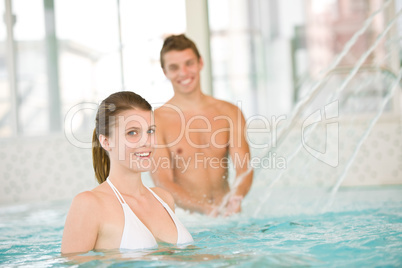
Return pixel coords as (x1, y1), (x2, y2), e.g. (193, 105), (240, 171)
(61, 91), (193, 254)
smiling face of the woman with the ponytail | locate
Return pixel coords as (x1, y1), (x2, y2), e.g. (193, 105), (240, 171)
(108, 109), (155, 172)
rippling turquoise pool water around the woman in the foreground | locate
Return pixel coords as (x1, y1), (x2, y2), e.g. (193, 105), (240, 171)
(0, 186), (402, 267)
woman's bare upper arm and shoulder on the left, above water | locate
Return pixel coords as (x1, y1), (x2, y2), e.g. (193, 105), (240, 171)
(61, 191), (100, 254)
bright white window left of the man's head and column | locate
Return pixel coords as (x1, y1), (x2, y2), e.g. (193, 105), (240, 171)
(0, 0), (186, 138)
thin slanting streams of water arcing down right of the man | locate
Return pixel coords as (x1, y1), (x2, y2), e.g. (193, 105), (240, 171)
(232, 1), (402, 216)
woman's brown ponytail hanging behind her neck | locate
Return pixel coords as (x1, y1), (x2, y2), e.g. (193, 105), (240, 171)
(92, 128), (110, 184)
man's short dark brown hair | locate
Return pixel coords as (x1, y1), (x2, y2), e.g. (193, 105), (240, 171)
(160, 34), (201, 68)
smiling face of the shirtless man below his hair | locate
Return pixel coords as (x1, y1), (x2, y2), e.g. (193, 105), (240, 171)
(163, 48), (203, 94)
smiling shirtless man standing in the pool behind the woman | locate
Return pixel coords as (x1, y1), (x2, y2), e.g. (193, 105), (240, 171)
(151, 35), (253, 216)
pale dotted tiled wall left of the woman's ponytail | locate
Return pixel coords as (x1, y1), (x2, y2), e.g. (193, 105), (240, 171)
(0, 135), (97, 204)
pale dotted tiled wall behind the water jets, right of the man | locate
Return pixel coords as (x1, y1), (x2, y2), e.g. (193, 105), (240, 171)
(253, 119), (402, 191)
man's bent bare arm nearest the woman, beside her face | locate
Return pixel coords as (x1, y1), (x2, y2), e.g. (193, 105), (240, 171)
(151, 129), (215, 215)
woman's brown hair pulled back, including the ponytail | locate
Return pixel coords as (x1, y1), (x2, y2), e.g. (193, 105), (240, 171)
(92, 91), (152, 184)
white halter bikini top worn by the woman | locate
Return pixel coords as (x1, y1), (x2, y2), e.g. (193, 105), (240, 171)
(106, 179), (194, 249)
